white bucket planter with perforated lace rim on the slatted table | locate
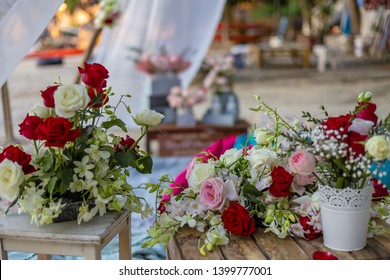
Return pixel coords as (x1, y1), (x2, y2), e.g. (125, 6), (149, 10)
(319, 183), (373, 251)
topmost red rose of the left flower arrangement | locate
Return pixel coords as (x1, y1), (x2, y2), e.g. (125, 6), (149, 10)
(79, 62), (109, 93)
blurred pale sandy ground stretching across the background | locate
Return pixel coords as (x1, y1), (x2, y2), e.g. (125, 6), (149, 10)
(0, 52), (390, 149)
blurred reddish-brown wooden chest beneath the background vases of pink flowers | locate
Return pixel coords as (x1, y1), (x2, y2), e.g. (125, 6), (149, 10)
(146, 120), (249, 156)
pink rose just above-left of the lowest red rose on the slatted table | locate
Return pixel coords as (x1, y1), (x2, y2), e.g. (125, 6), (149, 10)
(200, 178), (226, 210)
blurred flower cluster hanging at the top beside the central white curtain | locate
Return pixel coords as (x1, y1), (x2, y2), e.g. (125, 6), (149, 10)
(94, 0), (121, 28)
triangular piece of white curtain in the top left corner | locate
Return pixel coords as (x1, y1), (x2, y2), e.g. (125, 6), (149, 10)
(0, 0), (64, 86)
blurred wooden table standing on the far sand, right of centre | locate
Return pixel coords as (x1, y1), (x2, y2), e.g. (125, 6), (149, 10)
(251, 41), (310, 69)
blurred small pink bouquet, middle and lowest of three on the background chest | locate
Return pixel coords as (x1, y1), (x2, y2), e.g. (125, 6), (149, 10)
(167, 86), (206, 108)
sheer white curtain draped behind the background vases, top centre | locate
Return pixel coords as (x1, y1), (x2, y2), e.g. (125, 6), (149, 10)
(95, 0), (225, 127)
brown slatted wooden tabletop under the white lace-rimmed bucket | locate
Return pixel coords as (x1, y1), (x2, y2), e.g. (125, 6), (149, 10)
(167, 225), (390, 260)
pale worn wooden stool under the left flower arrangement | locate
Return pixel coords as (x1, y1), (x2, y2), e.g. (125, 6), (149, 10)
(0, 210), (131, 260)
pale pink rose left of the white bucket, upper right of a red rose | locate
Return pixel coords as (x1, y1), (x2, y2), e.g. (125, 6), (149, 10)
(288, 150), (316, 175)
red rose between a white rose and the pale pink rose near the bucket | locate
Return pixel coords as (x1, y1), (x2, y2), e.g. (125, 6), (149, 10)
(268, 166), (294, 197)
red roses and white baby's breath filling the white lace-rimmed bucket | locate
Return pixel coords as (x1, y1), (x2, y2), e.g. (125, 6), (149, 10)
(290, 92), (390, 189)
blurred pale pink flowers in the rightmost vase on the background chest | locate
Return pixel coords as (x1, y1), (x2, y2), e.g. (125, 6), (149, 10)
(202, 55), (234, 93)
